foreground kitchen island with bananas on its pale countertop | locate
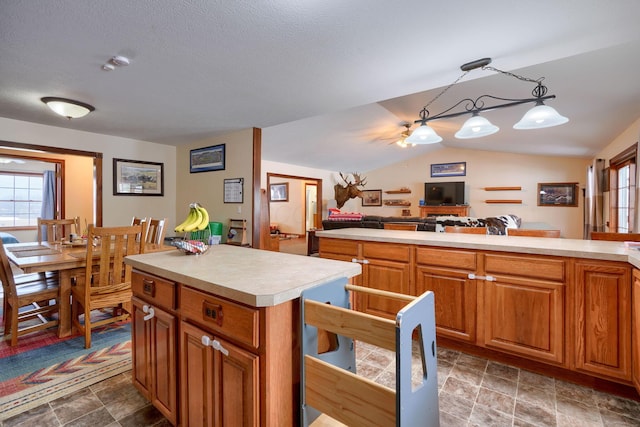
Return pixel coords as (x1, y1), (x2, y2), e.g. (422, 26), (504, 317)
(126, 245), (361, 426)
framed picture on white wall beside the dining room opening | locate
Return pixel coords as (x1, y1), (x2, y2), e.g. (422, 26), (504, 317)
(113, 159), (164, 196)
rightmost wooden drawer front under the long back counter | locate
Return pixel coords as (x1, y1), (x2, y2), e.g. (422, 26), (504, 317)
(485, 254), (565, 282)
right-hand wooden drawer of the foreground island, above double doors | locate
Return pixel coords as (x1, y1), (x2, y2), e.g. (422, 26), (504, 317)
(180, 286), (260, 348)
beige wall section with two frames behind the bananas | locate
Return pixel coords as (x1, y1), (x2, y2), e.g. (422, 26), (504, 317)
(176, 129), (253, 243)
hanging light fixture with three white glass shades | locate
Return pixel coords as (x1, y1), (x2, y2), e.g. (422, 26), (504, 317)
(405, 58), (569, 144)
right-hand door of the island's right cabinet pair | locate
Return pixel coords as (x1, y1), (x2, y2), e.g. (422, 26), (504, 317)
(214, 338), (260, 427)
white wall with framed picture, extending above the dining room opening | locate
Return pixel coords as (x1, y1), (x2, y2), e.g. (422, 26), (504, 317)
(0, 116), (176, 231)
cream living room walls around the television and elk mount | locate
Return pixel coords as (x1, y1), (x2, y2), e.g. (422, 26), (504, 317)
(262, 147), (590, 239)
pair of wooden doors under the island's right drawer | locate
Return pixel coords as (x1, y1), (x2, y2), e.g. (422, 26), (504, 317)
(180, 321), (260, 427)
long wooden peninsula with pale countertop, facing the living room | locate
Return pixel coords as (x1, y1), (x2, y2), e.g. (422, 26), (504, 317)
(316, 228), (640, 399)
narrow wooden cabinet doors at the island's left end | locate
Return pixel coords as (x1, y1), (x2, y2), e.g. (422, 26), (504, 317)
(132, 297), (178, 425)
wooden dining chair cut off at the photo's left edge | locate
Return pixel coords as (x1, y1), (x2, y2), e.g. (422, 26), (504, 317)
(0, 240), (60, 346)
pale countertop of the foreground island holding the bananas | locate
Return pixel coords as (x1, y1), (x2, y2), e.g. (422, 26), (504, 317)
(125, 245), (362, 307)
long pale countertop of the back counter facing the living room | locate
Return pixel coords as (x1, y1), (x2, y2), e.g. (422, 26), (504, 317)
(316, 228), (640, 268)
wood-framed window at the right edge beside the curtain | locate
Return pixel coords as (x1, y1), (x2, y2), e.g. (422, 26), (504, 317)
(609, 145), (637, 233)
